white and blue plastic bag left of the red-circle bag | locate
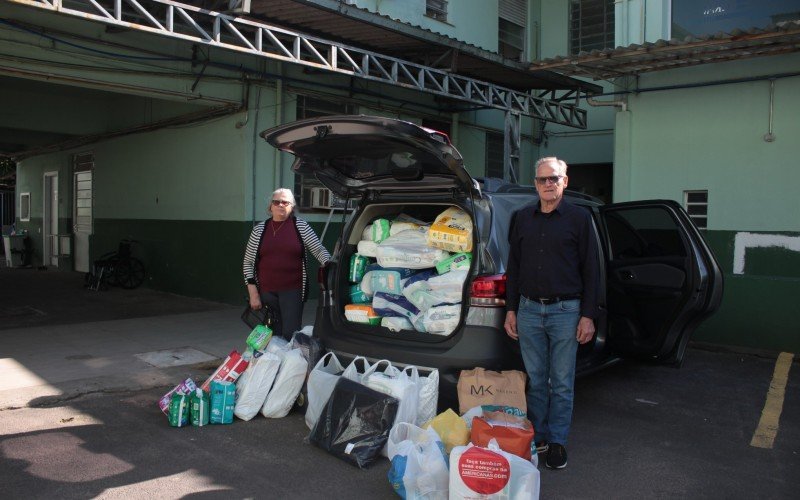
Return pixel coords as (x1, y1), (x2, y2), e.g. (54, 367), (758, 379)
(388, 424), (449, 500)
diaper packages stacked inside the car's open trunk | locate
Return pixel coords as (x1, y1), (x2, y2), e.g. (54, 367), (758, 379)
(344, 207), (472, 335)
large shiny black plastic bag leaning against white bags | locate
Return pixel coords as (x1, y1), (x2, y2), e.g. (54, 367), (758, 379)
(308, 378), (399, 469)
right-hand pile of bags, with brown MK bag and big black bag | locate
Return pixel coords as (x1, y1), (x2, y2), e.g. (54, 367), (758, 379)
(305, 353), (539, 499)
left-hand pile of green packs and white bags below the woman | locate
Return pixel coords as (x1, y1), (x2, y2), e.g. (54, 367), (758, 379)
(159, 325), (323, 427)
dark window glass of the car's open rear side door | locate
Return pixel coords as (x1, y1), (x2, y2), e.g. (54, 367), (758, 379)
(606, 207), (687, 260)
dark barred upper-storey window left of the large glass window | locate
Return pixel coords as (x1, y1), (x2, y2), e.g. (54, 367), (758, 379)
(569, 0), (614, 54)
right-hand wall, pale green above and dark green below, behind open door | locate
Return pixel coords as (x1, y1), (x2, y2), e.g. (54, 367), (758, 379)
(614, 54), (800, 352)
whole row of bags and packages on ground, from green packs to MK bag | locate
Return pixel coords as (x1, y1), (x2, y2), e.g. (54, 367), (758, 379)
(159, 316), (539, 499)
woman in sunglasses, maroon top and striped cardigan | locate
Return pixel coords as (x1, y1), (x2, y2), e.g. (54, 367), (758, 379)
(242, 188), (331, 339)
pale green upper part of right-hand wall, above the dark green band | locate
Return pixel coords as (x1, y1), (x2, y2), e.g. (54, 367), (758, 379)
(614, 54), (800, 231)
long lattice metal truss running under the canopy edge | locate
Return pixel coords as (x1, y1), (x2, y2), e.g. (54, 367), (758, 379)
(0, 0), (587, 129)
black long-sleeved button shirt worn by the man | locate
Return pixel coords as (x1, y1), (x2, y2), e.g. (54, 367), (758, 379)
(506, 199), (600, 318)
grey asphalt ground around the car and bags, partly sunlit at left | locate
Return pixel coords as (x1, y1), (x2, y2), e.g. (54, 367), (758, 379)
(0, 269), (800, 499)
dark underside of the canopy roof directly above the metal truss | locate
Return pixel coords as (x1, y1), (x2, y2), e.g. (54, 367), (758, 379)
(244, 0), (602, 94)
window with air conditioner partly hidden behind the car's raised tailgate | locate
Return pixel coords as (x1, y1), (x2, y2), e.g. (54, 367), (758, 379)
(294, 95), (356, 210)
